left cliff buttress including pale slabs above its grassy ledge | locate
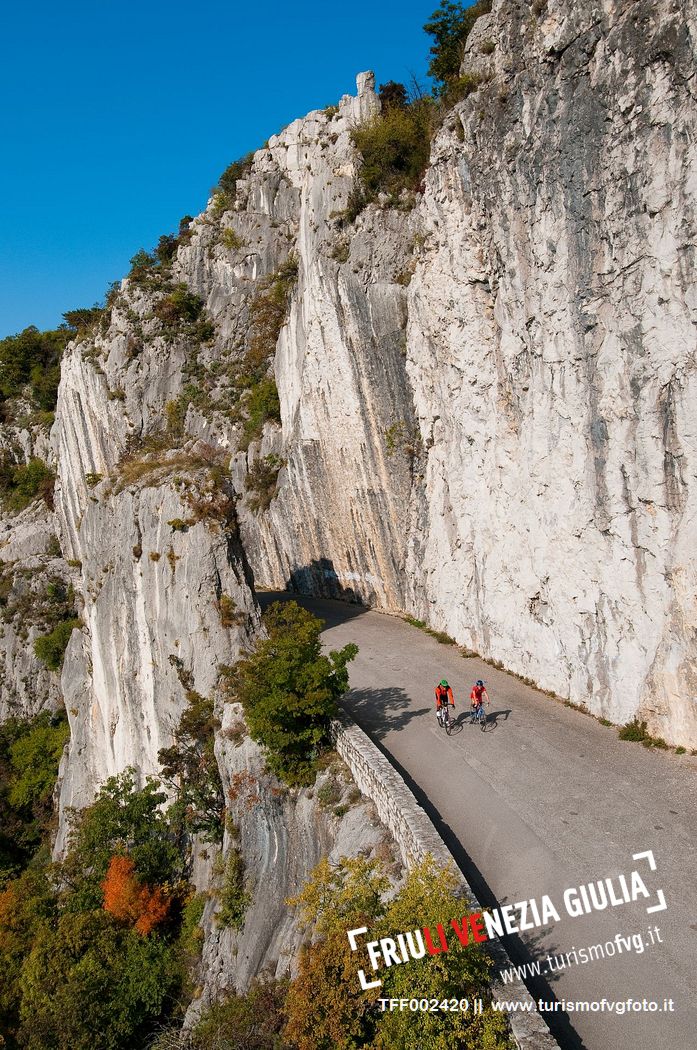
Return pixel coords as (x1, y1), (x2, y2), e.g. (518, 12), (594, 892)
(54, 317), (258, 835)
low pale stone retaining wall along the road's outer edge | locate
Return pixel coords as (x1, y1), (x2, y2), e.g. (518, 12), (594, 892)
(332, 712), (558, 1050)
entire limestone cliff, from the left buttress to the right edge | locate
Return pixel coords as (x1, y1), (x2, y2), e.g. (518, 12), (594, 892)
(0, 0), (697, 1007)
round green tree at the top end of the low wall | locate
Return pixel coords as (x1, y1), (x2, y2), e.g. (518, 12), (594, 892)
(228, 602), (358, 783)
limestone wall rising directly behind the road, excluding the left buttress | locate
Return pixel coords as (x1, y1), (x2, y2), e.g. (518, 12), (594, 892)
(142, 0), (697, 744)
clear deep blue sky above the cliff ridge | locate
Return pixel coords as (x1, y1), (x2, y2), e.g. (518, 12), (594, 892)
(0, 0), (438, 337)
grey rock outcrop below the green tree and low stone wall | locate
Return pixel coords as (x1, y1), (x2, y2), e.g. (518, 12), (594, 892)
(188, 704), (402, 1024)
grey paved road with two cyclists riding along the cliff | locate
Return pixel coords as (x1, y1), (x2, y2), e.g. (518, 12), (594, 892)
(262, 599), (697, 1050)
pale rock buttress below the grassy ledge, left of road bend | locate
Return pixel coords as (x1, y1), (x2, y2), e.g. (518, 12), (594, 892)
(53, 483), (257, 848)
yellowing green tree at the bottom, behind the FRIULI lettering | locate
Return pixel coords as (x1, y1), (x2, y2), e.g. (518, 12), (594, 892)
(286, 857), (512, 1050)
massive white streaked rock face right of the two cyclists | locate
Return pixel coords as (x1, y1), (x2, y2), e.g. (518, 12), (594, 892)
(407, 2), (697, 746)
